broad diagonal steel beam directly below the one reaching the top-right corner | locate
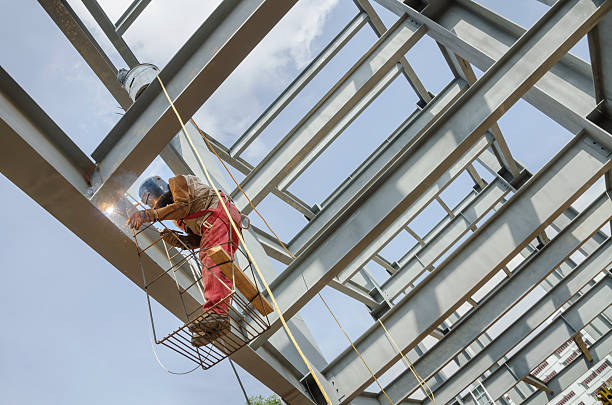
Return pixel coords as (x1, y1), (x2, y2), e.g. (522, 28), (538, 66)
(323, 131), (612, 399)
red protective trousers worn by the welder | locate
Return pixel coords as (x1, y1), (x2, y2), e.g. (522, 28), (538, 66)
(199, 196), (242, 315)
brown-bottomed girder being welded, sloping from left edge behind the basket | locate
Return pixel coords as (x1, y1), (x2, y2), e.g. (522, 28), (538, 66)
(0, 69), (313, 405)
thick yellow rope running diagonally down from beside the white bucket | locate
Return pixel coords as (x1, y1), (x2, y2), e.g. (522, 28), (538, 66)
(157, 76), (332, 405)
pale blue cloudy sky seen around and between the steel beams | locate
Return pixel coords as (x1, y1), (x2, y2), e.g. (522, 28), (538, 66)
(0, 0), (601, 404)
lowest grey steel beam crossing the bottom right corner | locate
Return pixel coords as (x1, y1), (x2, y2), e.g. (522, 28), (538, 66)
(522, 332), (612, 405)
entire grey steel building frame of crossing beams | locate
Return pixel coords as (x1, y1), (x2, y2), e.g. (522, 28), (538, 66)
(0, 0), (612, 405)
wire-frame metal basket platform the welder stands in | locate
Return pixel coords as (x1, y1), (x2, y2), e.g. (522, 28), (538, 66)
(134, 211), (270, 369)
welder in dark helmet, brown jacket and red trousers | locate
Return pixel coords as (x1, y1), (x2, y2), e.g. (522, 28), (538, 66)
(127, 175), (242, 347)
